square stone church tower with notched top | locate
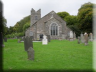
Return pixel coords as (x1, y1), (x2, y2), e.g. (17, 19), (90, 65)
(30, 8), (41, 26)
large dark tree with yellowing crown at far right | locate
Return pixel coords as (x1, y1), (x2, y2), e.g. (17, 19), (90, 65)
(78, 2), (93, 33)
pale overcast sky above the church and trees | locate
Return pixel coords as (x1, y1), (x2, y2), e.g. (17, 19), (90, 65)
(1, 0), (96, 27)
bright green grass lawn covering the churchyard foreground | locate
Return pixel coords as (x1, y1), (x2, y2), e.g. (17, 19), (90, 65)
(3, 39), (92, 70)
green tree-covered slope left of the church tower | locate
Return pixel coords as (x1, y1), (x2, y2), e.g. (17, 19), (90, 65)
(5, 15), (30, 38)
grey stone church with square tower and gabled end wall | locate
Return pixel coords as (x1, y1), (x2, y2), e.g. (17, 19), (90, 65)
(25, 8), (71, 40)
